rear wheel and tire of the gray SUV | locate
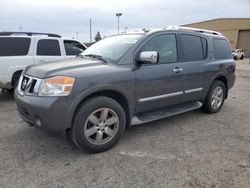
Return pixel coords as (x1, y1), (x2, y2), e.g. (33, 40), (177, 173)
(201, 80), (227, 114)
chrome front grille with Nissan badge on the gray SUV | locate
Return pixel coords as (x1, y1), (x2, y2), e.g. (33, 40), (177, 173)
(18, 74), (41, 95)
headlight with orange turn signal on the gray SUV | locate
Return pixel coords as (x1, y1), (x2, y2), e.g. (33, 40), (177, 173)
(38, 76), (75, 96)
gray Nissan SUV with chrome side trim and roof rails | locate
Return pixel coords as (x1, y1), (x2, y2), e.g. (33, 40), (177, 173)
(15, 27), (235, 152)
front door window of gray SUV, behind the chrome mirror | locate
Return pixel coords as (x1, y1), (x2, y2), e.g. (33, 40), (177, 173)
(140, 34), (177, 63)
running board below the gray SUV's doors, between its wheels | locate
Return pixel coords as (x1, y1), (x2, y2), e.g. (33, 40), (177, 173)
(131, 101), (202, 125)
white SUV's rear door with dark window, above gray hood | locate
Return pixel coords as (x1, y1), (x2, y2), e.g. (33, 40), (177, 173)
(34, 38), (64, 63)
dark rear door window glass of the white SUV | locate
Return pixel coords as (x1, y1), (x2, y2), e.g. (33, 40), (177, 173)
(36, 39), (61, 56)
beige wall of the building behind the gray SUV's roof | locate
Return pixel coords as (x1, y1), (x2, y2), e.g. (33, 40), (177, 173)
(182, 18), (250, 51)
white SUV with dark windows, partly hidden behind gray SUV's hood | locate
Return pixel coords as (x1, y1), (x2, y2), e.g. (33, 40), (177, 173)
(0, 32), (86, 90)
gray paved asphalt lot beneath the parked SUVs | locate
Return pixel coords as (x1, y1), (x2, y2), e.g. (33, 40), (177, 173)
(0, 60), (250, 188)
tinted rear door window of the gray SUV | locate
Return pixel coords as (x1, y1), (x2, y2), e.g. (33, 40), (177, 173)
(181, 34), (204, 61)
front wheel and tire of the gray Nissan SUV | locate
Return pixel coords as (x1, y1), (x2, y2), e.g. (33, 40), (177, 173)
(71, 96), (126, 153)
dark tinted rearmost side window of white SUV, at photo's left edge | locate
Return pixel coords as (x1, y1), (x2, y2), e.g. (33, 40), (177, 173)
(0, 37), (30, 56)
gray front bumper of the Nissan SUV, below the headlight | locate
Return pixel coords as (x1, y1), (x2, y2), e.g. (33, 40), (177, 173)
(15, 90), (72, 132)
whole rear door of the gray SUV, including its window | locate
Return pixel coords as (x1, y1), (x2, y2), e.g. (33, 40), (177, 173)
(179, 34), (210, 102)
